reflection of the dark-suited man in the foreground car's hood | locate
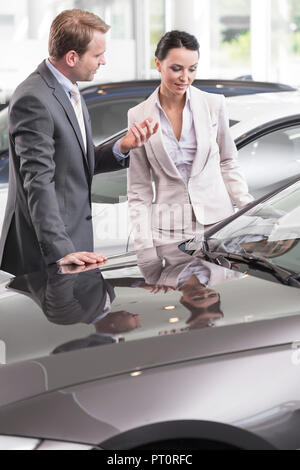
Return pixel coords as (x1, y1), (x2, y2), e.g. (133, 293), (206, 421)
(9, 266), (141, 336)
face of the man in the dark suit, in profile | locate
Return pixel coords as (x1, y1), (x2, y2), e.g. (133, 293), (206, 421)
(73, 31), (106, 82)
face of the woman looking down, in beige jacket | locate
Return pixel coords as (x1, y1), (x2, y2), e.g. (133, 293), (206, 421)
(155, 47), (199, 96)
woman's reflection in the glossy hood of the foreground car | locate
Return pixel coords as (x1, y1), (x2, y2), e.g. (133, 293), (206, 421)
(137, 243), (242, 334)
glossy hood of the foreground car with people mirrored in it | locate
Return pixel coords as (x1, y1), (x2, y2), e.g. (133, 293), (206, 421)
(0, 244), (300, 404)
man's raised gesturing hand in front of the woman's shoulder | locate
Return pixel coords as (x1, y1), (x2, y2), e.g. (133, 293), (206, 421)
(120, 118), (159, 154)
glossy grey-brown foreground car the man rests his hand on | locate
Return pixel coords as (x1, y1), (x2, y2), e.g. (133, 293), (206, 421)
(0, 179), (300, 450)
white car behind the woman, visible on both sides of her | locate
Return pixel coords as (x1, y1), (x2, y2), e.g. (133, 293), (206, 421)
(92, 91), (300, 254)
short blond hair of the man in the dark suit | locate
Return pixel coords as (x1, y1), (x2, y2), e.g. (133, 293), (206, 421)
(49, 9), (110, 60)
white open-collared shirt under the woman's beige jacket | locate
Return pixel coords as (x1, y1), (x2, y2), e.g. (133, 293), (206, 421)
(156, 89), (197, 184)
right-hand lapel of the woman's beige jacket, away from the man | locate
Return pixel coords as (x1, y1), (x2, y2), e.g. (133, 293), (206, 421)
(190, 87), (211, 176)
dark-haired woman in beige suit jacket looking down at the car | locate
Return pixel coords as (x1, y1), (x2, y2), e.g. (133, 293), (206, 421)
(128, 31), (253, 249)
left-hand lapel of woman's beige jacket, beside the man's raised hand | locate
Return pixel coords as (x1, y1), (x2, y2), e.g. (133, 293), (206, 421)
(144, 88), (182, 179)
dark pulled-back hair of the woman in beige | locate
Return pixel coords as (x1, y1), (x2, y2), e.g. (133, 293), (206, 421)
(155, 30), (200, 60)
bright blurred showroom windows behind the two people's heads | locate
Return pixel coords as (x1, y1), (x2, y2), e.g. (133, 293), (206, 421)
(0, 0), (300, 95)
